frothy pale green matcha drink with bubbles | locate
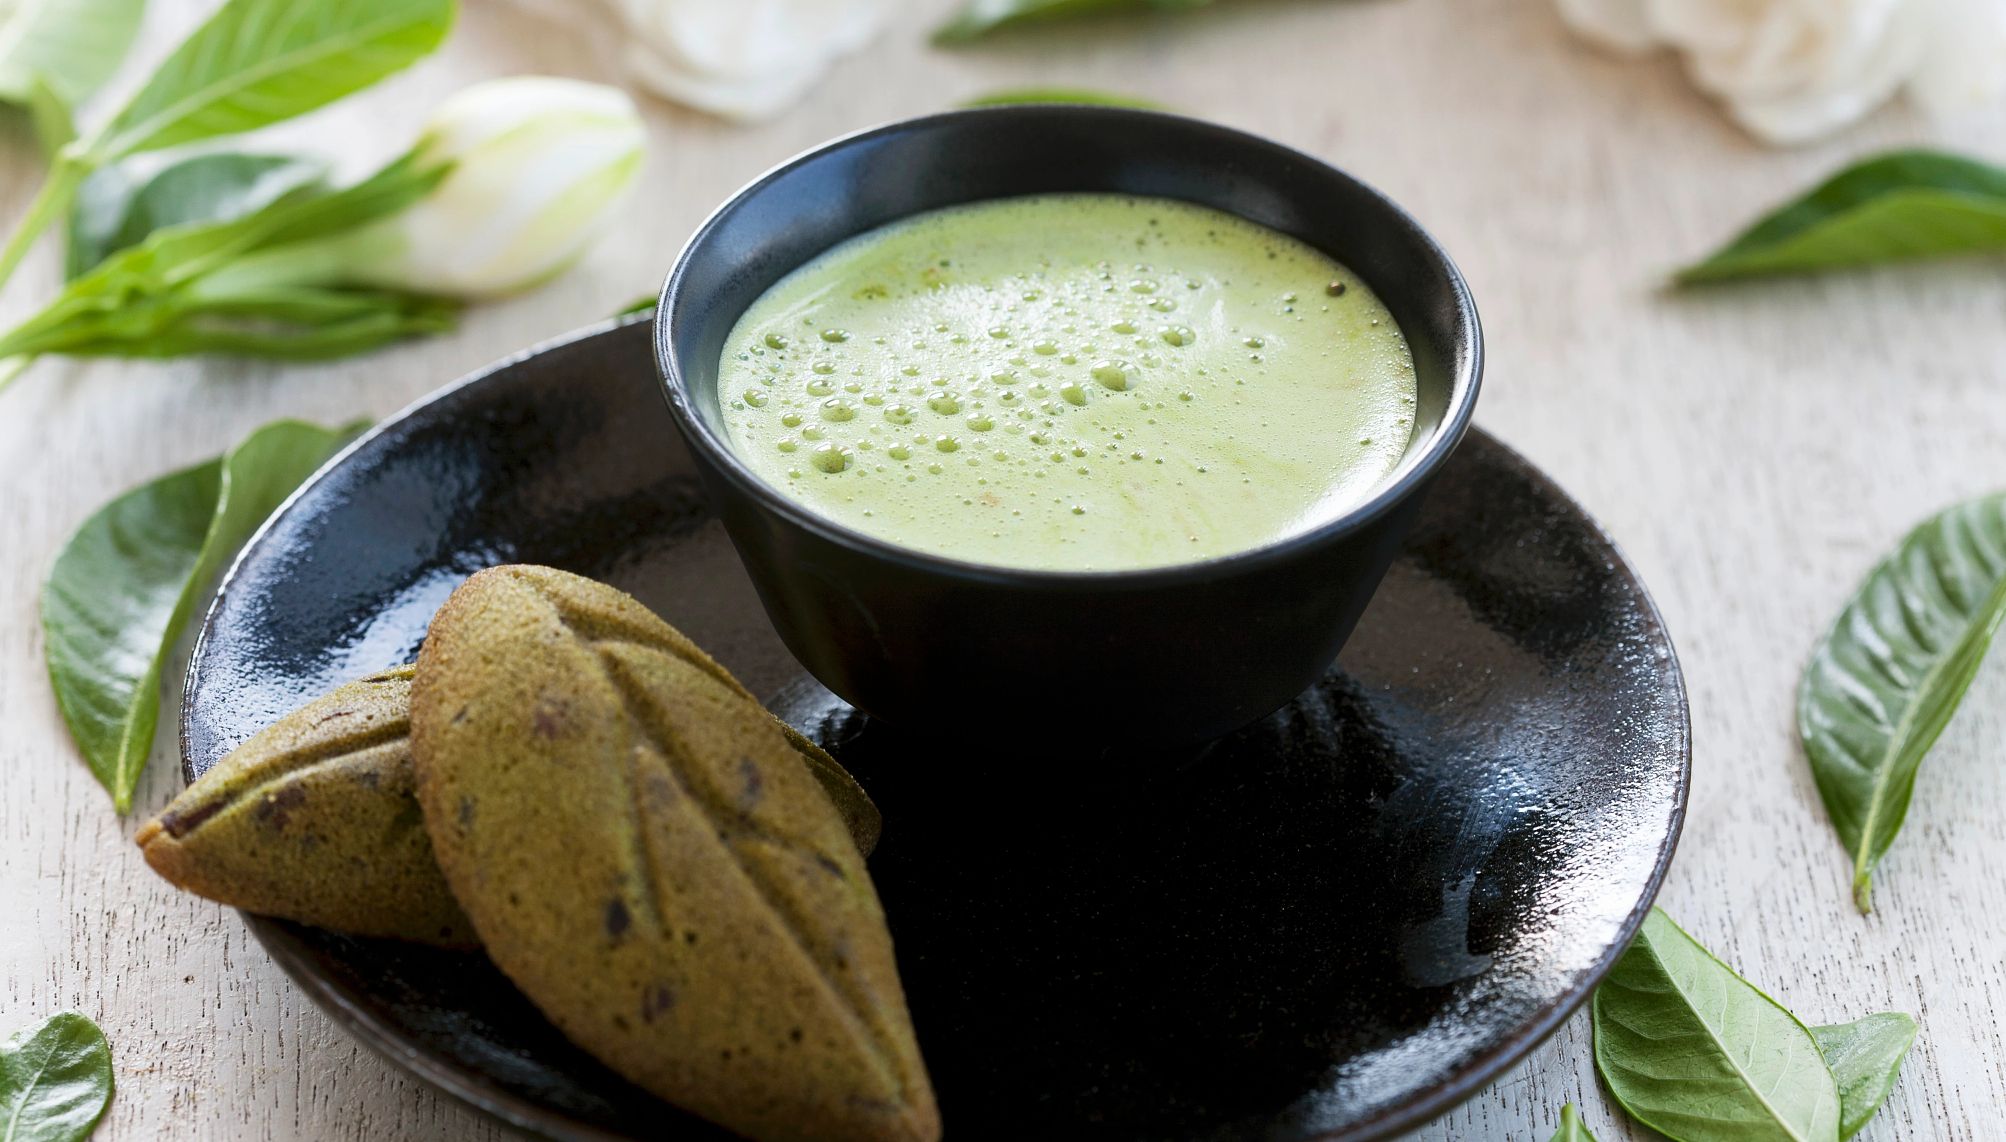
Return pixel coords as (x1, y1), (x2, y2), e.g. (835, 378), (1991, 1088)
(718, 195), (1414, 570)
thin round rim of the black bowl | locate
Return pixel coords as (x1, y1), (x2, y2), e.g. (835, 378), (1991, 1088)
(652, 104), (1484, 592)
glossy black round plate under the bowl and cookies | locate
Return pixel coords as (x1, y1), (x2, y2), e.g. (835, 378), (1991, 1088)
(183, 317), (1687, 1140)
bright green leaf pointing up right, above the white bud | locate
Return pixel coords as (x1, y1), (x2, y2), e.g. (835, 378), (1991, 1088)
(86, 0), (455, 163)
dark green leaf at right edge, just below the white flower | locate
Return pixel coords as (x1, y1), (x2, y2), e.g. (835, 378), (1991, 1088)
(1677, 151), (2006, 285)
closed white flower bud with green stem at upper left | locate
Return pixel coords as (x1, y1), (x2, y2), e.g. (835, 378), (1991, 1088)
(345, 76), (646, 297)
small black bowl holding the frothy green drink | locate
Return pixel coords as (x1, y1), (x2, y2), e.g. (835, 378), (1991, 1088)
(656, 106), (1482, 749)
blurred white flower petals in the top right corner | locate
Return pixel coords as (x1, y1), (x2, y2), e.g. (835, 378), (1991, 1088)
(1559, 0), (2006, 142)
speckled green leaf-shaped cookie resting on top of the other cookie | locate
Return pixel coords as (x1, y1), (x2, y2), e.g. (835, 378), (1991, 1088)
(411, 566), (939, 1142)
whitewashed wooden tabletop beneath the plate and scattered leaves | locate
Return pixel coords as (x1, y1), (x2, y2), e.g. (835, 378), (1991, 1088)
(0, 0), (2006, 1142)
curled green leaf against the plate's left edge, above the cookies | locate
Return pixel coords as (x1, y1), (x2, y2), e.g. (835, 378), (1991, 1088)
(42, 419), (363, 813)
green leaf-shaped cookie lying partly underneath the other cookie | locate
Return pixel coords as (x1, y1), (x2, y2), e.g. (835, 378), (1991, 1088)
(134, 666), (475, 947)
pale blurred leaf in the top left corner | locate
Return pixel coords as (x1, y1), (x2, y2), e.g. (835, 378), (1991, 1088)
(0, 0), (146, 106)
